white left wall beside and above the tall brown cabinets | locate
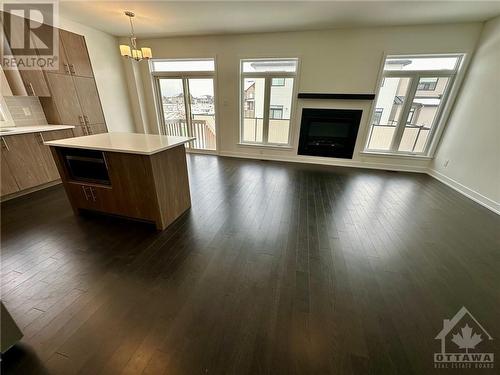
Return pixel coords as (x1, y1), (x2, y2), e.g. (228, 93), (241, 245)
(59, 17), (135, 132)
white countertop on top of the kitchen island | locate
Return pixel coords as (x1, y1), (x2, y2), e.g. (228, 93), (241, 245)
(45, 133), (196, 155)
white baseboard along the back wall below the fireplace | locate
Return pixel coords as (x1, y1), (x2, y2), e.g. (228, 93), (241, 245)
(219, 151), (427, 173)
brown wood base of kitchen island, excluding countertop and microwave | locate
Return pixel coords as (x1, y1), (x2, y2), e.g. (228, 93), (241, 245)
(51, 145), (191, 229)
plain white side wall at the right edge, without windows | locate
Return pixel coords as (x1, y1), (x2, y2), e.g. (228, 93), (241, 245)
(430, 17), (500, 213)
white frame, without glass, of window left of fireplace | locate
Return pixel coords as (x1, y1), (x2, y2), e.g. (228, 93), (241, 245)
(238, 57), (300, 148)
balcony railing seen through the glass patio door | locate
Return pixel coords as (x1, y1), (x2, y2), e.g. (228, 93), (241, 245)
(162, 115), (216, 150)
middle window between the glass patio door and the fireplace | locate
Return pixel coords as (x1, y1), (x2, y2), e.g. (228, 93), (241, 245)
(240, 59), (298, 146)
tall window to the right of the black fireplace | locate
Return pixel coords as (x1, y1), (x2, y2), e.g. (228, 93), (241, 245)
(366, 55), (463, 155)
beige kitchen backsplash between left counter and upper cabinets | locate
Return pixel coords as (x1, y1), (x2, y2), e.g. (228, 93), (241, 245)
(4, 96), (47, 126)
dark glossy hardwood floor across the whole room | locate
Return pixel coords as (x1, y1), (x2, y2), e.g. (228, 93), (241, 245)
(1, 155), (500, 375)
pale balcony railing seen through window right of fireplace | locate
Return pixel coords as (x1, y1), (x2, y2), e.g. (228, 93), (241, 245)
(368, 124), (431, 153)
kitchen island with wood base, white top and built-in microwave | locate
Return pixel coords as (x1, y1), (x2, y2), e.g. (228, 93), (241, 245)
(45, 133), (195, 230)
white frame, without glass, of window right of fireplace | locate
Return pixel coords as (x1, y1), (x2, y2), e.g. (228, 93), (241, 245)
(362, 53), (467, 158)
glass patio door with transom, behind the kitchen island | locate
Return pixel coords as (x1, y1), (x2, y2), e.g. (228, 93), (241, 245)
(150, 59), (217, 151)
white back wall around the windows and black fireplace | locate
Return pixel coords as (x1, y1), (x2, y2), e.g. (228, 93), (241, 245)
(131, 23), (482, 171)
